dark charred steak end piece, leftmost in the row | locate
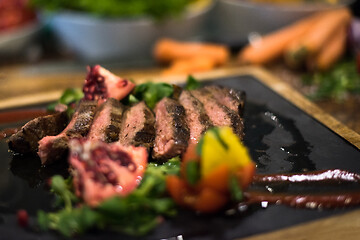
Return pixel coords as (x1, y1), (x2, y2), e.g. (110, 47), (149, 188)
(8, 111), (68, 154)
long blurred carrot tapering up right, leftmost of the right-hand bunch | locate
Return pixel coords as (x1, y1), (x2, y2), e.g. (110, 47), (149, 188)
(238, 11), (322, 64)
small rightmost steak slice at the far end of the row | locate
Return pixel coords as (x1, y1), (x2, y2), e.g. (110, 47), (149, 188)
(204, 85), (246, 116)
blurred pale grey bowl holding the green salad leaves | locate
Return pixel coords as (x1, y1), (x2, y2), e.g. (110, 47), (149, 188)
(43, 0), (213, 62)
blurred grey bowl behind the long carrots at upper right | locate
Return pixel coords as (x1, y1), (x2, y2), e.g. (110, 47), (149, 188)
(211, 0), (353, 46)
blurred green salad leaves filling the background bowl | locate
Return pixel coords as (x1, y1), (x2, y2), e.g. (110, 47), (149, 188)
(30, 0), (193, 20)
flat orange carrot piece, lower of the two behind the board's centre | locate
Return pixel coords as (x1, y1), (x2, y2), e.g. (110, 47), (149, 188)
(162, 56), (216, 76)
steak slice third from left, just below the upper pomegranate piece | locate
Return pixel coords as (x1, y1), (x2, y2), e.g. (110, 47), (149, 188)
(87, 98), (125, 143)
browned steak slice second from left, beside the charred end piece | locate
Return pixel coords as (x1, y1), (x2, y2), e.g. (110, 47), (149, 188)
(38, 101), (97, 164)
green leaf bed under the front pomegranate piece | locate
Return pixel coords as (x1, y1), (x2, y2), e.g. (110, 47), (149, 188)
(38, 158), (180, 237)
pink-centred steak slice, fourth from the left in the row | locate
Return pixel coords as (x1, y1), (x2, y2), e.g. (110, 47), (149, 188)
(119, 102), (155, 149)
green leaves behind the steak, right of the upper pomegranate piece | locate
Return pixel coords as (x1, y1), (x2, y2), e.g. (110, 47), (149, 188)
(129, 82), (174, 108)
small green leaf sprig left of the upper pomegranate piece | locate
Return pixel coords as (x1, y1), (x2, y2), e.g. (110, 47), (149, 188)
(47, 88), (84, 116)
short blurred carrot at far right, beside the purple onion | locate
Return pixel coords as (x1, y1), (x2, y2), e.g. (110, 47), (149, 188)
(310, 25), (346, 70)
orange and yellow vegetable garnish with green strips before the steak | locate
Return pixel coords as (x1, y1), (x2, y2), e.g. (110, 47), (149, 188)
(166, 127), (255, 212)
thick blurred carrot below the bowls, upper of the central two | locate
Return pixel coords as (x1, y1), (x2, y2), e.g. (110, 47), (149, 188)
(154, 39), (229, 65)
